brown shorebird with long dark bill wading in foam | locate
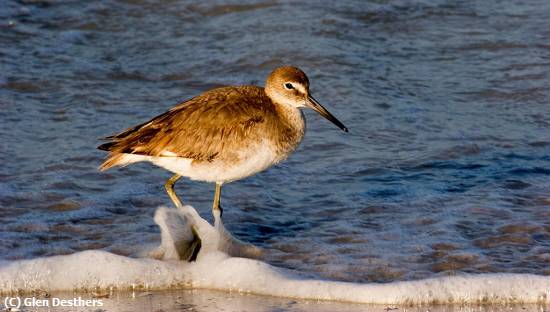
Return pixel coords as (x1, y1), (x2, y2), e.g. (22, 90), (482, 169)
(98, 66), (348, 258)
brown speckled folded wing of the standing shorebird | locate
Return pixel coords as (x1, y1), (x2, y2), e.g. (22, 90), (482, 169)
(98, 86), (275, 161)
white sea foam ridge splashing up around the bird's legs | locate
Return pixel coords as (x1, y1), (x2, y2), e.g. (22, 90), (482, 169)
(0, 206), (550, 304)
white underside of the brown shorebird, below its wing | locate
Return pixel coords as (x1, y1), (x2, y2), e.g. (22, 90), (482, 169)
(119, 142), (288, 183)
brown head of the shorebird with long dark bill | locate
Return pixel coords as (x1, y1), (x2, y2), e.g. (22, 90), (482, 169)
(265, 66), (348, 132)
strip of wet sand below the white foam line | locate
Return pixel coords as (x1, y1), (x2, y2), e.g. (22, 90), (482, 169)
(3, 289), (550, 312)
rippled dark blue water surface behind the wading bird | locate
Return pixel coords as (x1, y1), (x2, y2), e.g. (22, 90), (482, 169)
(0, 0), (550, 282)
